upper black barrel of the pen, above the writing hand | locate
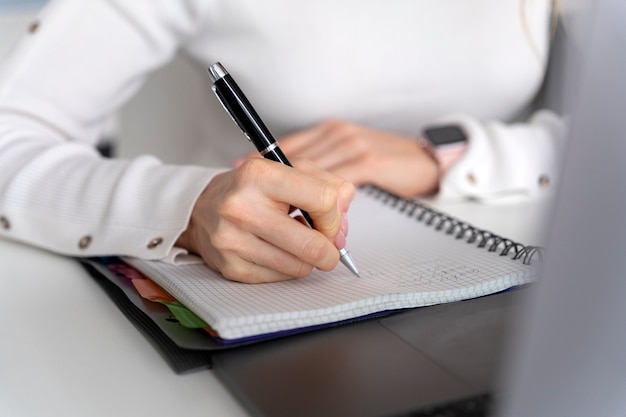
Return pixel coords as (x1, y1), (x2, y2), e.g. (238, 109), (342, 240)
(213, 74), (276, 152)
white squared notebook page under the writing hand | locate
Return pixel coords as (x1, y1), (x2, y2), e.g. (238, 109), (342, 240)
(127, 189), (536, 339)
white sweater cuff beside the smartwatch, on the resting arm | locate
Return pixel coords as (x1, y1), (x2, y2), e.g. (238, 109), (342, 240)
(439, 110), (566, 201)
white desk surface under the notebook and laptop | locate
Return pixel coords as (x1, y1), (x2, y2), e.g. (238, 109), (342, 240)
(0, 196), (547, 417)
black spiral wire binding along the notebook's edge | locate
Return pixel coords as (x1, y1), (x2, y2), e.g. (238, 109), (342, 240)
(362, 185), (543, 265)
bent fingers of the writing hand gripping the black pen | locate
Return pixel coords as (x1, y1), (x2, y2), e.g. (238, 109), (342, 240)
(228, 160), (354, 273)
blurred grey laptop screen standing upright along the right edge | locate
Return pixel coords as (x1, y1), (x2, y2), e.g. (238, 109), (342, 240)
(497, 0), (626, 417)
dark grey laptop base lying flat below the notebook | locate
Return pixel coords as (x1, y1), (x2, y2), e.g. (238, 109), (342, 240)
(212, 290), (526, 417)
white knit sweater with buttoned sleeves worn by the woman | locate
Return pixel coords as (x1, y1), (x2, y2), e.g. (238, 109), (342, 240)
(0, 0), (562, 258)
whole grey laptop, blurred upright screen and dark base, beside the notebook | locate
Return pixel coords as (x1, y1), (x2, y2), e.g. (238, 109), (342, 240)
(213, 0), (626, 417)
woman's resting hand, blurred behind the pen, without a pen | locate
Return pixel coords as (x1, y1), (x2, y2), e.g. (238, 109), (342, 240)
(239, 120), (439, 197)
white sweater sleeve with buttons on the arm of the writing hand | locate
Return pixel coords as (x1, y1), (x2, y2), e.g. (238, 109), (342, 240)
(0, 0), (216, 259)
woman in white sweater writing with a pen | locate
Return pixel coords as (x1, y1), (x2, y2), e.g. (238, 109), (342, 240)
(0, 0), (562, 282)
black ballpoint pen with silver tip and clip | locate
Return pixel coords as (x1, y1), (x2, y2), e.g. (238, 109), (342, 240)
(208, 62), (359, 276)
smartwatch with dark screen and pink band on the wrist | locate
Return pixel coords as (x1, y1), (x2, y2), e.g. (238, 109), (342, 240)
(418, 125), (467, 175)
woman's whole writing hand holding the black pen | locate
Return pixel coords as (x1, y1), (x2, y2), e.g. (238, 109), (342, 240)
(177, 158), (355, 283)
